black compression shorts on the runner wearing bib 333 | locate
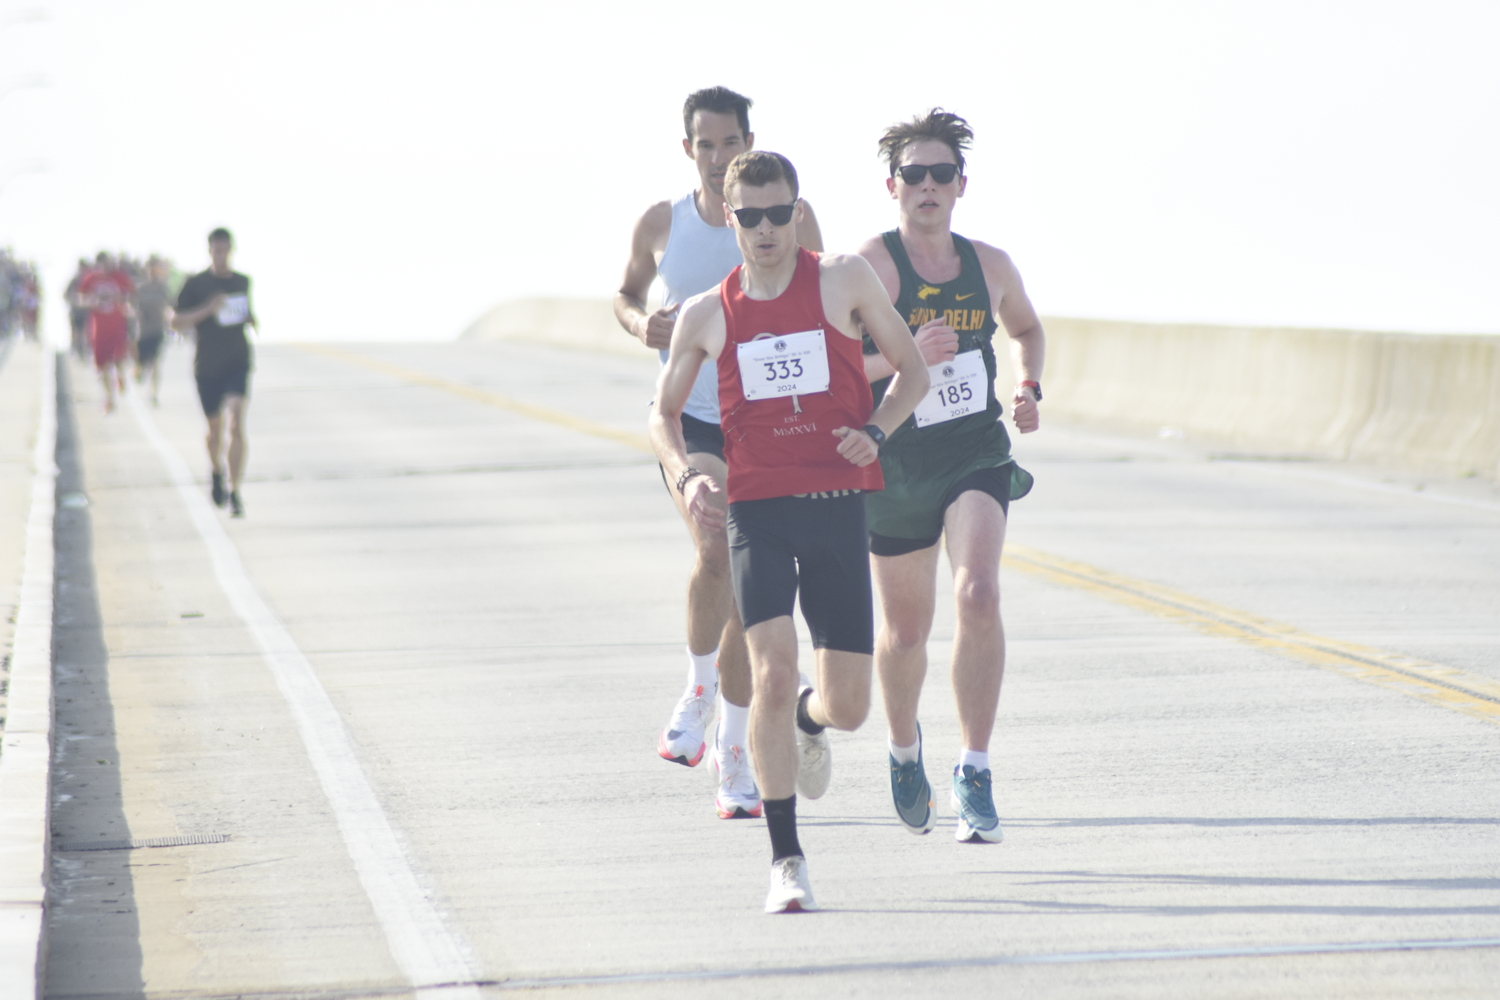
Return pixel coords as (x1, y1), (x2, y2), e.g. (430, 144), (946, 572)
(729, 490), (875, 654)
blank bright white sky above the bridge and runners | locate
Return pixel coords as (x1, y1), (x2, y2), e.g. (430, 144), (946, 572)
(0, 0), (1500, 339)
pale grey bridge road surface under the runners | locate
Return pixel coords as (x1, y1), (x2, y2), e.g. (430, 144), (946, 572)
(32, 342), (1500, 1000)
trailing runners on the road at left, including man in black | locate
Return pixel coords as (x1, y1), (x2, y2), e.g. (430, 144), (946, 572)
(65, 228), (257, 517)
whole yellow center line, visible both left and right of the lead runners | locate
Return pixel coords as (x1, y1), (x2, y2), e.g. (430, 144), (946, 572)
(299, 343), (1500, 724)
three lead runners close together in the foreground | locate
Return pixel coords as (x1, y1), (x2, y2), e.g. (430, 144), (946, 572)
(615, 87), (1046, 913)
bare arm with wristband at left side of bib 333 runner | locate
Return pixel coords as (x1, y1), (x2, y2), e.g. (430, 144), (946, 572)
(650, 295), (725, 528)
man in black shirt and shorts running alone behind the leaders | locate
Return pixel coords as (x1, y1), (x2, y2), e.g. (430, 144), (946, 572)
(173, 229), (260, 517)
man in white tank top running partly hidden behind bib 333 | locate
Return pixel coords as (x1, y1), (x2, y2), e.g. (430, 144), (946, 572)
(615, 87), (824, 819)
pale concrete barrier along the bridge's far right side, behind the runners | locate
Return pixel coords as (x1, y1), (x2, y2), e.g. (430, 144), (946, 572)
(462, 298), (1500, 480)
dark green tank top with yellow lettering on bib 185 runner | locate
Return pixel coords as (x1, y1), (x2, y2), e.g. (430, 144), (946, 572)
(864, 229), (1010, 454)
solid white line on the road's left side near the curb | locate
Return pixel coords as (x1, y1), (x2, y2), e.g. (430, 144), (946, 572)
(126, 393), (480, 1000)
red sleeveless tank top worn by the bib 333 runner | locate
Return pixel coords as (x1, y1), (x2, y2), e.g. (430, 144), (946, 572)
(719, 249), (885, 502)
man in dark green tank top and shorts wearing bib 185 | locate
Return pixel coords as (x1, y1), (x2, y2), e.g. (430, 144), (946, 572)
(860, 108), (1046, 843)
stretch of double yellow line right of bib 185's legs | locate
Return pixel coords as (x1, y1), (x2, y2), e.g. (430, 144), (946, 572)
(1004, 546), (1500, 726)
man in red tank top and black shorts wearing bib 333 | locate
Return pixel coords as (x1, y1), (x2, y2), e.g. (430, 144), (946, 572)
(651, 151), (927, 913)
